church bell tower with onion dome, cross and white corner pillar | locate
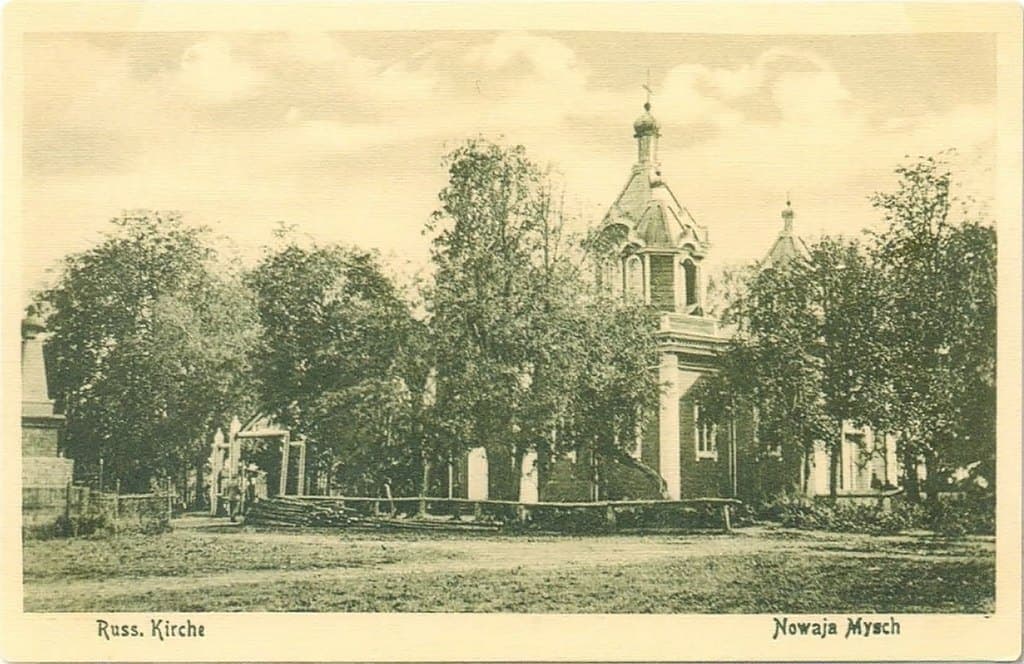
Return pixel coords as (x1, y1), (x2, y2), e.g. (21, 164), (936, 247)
(597, 94), (733, 499)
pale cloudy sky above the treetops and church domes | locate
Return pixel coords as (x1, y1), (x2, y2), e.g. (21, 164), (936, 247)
(22, 31), (996, 290)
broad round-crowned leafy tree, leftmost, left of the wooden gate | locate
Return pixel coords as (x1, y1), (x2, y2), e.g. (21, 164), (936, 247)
(39, 211), (254, 491)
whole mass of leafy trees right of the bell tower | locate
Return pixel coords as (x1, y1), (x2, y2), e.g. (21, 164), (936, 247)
(706, 156), (995, 496)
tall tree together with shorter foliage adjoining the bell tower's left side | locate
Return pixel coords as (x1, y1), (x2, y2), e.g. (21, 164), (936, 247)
(428, 140), (656, 498)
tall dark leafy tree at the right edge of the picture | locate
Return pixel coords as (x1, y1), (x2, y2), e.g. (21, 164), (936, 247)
(872, 155), (995, 498)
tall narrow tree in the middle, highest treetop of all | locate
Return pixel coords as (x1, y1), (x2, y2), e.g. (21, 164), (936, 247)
(428, 140), (555, 497)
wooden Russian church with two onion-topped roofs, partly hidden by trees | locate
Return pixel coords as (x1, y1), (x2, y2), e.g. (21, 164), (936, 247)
(458, 101), (898, 502)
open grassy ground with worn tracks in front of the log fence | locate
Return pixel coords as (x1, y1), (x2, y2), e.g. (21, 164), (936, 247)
(24, 518), (995, 613)
